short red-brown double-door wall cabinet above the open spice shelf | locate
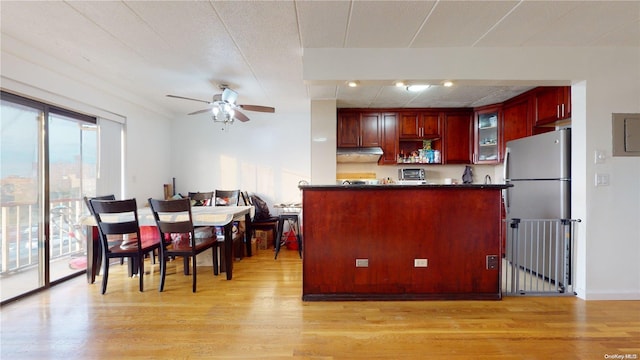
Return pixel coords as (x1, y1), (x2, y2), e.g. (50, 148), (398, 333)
(398, 111), (441, 140)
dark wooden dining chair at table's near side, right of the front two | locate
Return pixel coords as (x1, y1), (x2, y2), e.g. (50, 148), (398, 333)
(149, 198), (218, 292)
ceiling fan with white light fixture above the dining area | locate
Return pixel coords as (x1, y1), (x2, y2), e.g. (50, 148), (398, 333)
(167, 85), (276, 123)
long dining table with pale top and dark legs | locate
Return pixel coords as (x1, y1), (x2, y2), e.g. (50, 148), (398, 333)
(80, 206), (255, 284)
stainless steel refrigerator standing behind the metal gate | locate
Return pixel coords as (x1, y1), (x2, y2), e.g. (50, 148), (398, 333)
(504, 128), (571, 281)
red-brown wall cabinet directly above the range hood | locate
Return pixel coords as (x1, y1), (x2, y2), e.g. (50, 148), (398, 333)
(337, 109), (381, 147)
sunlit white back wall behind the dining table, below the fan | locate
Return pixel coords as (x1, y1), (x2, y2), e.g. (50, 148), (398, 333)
(167, 105), (311, 211)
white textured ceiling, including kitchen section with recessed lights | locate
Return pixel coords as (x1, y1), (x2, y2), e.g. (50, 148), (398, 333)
(0, 0), (640, 114)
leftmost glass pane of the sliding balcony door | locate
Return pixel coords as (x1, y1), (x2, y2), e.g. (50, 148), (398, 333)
(0, 98), (44, 300)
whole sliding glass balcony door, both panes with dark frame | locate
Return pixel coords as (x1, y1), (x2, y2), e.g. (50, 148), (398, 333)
(0, 93), (97, 302)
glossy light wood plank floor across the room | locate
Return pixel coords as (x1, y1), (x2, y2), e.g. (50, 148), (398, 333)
(0, 250), (640, 360)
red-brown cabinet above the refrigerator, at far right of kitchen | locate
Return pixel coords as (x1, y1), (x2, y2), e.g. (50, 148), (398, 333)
(535, 86), (571, 126)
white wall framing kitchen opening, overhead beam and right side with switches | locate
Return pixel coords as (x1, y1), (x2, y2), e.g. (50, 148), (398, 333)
(303, 47), (640, 299)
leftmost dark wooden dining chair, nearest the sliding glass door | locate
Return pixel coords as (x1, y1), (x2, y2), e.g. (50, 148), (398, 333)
(89, 199), (161, 294)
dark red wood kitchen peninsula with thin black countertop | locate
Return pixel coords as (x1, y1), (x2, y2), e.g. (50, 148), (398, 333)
(300, 184), (509, 301)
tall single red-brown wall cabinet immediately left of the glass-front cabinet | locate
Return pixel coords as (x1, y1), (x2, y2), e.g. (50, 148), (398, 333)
(442, 111), (473, 164)
